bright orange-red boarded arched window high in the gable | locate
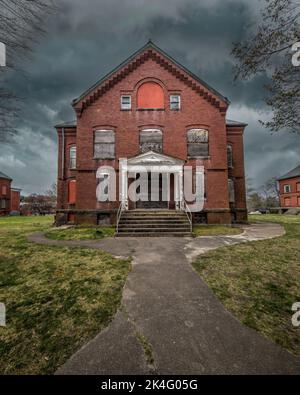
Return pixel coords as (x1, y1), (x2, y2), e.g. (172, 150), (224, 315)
(137, 82), (165, 110)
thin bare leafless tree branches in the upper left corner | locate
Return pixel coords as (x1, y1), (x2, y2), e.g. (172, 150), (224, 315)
(0, 0), (56, 141)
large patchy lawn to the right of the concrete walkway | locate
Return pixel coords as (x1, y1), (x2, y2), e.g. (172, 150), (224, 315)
(193, 215), (300, 356)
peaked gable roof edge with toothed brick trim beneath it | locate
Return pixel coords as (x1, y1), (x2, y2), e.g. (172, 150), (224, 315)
(72, 40), (230, 115)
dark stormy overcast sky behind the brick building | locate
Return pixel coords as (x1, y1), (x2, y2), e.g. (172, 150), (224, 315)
(0, 0), (300, 194)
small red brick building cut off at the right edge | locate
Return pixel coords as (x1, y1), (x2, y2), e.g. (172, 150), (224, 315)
(278, 166), (300, 209)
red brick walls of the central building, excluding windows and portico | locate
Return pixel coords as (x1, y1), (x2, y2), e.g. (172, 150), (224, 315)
(56, 43), (247, 224)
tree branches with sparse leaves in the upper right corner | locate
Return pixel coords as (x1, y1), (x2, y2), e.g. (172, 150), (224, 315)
(232, 0), (300, 133)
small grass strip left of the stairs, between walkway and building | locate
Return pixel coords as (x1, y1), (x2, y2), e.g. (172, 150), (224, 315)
(45, 227), (115, 240)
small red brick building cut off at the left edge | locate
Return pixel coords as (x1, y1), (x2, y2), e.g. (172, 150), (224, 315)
(0, 172), (21, 215)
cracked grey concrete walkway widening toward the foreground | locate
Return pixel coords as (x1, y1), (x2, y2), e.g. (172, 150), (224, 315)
(30, 224), (300, 374)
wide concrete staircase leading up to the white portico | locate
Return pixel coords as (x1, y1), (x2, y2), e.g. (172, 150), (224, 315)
(116, 210), (191, 237)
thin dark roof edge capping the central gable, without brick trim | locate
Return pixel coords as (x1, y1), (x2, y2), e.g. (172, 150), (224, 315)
(72, 40), (230, 106)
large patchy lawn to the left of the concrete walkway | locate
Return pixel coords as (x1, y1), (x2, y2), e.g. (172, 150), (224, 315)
(0, 217), (130, 374)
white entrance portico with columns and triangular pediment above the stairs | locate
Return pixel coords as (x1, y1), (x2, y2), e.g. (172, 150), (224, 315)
(119, 151), (185, 210)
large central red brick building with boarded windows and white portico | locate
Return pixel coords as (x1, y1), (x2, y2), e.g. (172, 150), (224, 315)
(56, 42), (247, 224)
